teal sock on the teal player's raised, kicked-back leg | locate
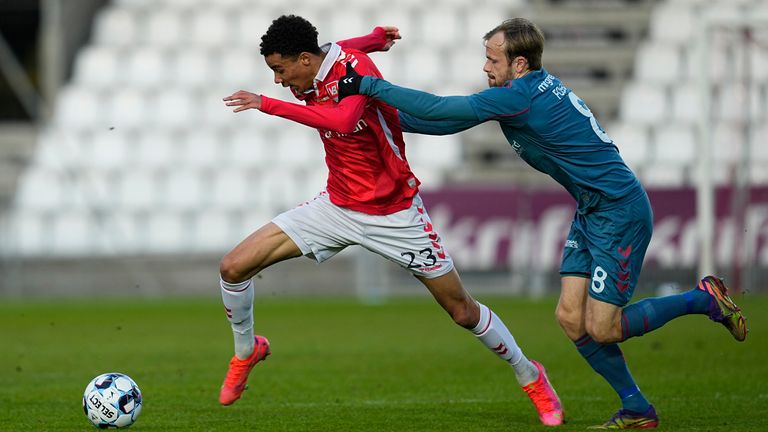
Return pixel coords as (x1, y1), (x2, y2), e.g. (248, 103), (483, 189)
(621, 289), (710, 341)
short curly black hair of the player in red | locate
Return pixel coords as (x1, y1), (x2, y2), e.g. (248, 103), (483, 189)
(260, 15), (321, 57)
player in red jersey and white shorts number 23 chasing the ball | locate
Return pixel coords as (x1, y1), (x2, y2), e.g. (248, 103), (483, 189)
(219, 15), (563, 426)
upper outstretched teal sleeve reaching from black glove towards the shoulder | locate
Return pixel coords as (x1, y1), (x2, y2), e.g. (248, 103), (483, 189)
(360, 76), (482, 122)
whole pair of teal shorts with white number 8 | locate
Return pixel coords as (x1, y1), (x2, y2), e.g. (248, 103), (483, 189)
(560, 191), (653, 306)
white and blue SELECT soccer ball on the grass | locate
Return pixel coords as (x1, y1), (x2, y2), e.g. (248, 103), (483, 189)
(83, 372), (141, 429)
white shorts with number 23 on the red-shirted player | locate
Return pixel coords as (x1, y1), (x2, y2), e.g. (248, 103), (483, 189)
(272, 191), (453, 279)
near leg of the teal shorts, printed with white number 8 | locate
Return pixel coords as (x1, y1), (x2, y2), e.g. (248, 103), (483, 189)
(585, 193), (653, 307)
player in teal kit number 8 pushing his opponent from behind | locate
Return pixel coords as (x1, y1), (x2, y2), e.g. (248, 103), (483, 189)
(339, 18), (747, 429)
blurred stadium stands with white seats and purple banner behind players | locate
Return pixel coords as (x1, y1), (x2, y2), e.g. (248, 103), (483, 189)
(0, 0), (768, 302)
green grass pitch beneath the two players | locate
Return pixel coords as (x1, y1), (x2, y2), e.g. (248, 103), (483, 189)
(0, 296), (768, 432)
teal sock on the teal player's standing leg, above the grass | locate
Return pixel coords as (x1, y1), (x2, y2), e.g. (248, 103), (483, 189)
(575, 335), (651, 413)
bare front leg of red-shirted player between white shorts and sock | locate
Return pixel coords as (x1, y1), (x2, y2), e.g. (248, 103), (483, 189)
(220, 222), (301, 282)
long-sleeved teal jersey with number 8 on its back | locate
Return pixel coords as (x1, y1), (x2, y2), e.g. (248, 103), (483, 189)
(360, 69), (642, 213)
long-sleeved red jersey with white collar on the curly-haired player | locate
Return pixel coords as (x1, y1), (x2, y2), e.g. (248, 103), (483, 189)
(261, 44), (420, 215)
